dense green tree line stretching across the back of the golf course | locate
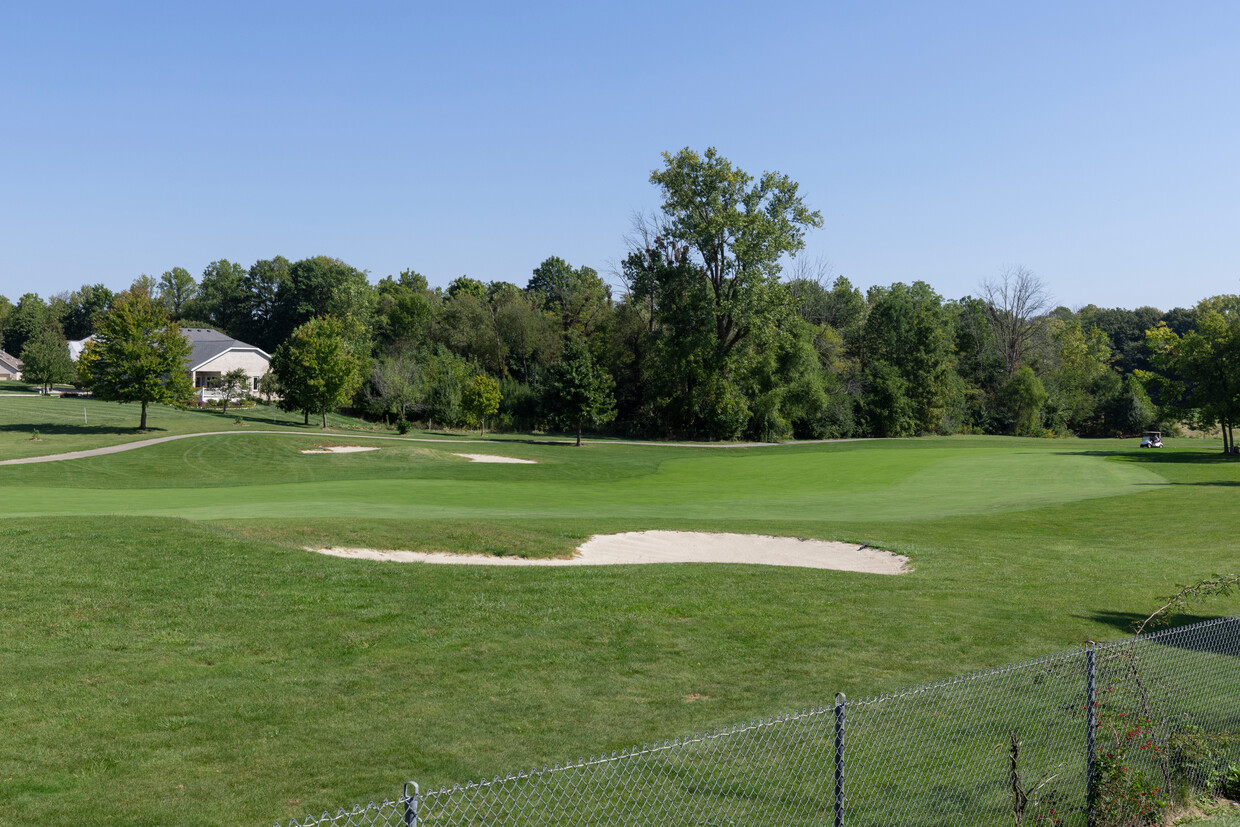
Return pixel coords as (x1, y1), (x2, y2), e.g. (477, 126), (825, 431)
(0, 149), (1240, 440)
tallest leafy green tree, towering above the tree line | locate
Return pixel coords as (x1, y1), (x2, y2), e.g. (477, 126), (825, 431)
(622, 148), (822, 439)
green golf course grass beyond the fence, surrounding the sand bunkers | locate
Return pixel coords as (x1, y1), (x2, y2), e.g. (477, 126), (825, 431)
(0, 424), (1240, 825)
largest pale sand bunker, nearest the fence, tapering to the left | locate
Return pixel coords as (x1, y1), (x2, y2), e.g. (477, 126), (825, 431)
(311, 531), (909, 574)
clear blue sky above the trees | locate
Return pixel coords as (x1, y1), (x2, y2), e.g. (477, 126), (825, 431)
(0, 0), (1240, 309)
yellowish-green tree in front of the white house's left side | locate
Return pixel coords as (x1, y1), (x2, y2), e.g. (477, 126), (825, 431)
(78, 290), (193, 430)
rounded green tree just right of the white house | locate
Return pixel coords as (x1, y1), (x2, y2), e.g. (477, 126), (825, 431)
(272, 316), (362, 428)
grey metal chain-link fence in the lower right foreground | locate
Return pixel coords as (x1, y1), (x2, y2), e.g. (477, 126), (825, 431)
(277, 617), (1240, 827)
